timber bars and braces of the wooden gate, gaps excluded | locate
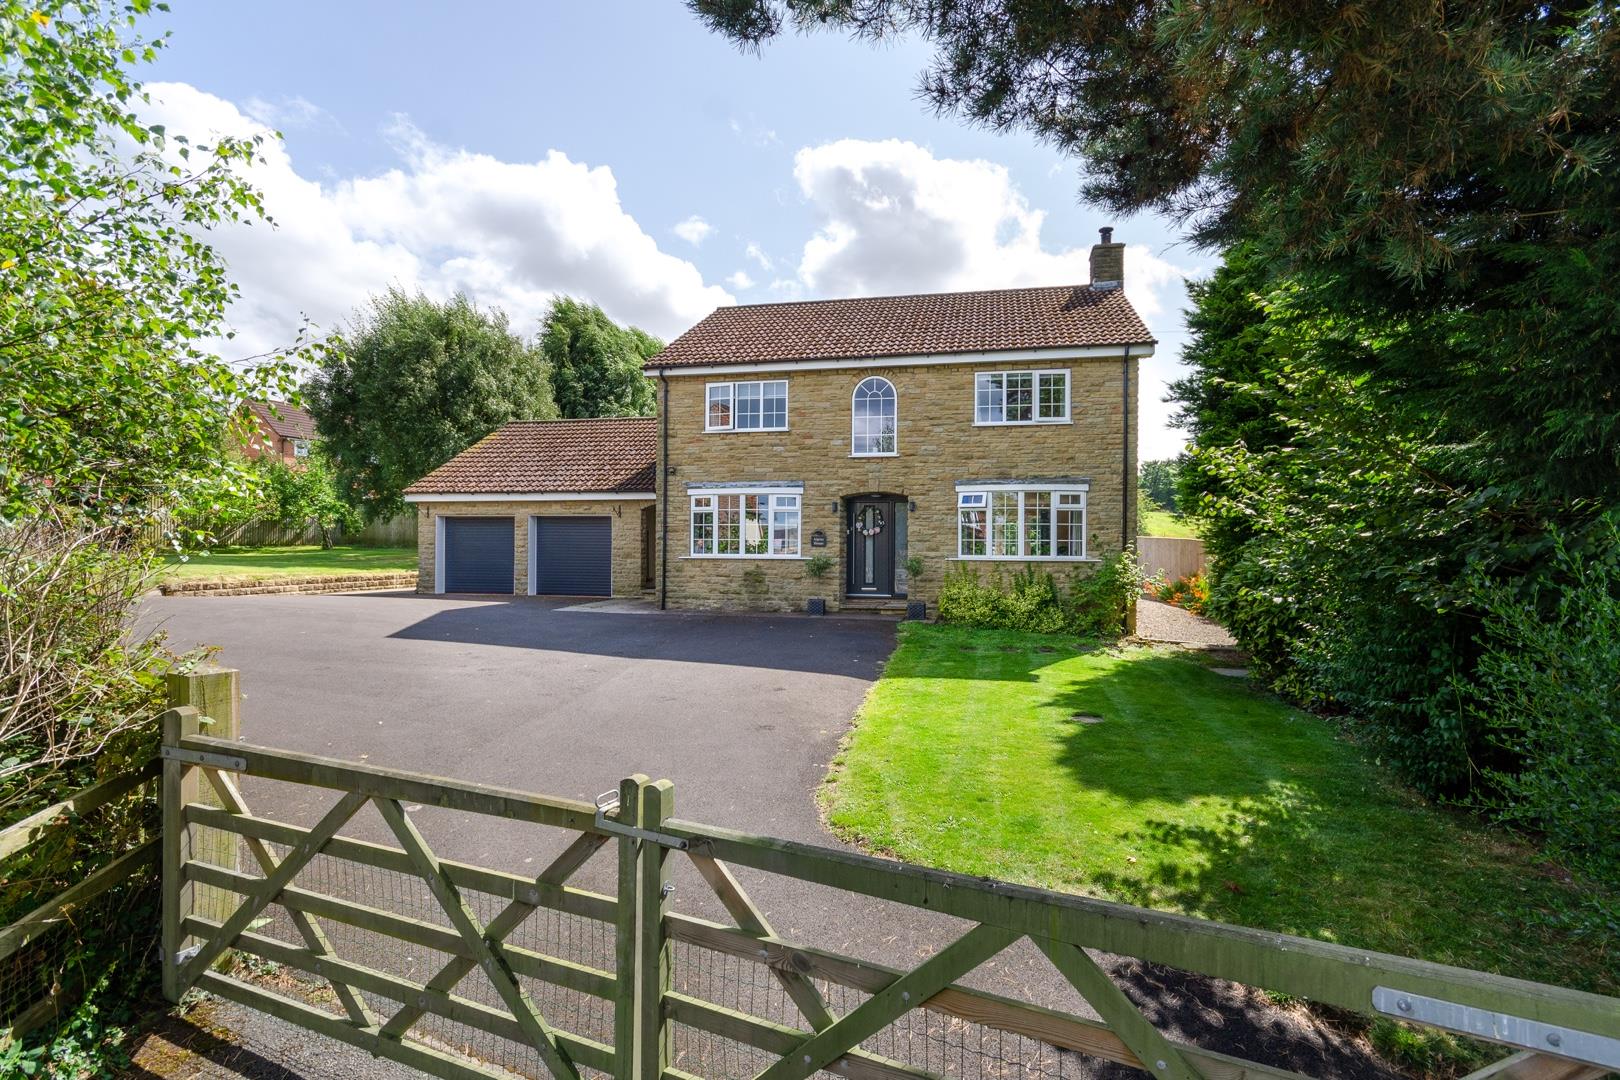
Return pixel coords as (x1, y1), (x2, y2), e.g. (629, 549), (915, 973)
(145, 670), (1620, 1080)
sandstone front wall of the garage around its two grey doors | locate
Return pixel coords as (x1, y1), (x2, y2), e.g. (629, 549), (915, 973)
(416, 497), (651, 596)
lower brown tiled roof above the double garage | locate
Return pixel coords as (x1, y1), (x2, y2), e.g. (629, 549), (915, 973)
(405, 416), (658, 495)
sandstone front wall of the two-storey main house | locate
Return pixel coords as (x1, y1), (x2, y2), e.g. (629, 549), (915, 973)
(658, 356), (1140, 610)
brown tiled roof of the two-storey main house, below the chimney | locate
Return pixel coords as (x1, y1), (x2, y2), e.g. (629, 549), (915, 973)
(646, 285), (1153, 369)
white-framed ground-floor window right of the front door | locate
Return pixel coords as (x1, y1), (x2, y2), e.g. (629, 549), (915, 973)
(956, 486), (1087, 560)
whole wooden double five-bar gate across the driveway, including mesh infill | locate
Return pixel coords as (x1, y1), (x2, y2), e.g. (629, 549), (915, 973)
(142, 670), (1620, 1080)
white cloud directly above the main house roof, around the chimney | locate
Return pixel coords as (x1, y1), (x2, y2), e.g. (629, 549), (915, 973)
(794, 139), (1184, 321)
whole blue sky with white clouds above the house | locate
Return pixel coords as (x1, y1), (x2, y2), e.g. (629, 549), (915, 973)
(146, 0), (1210, 458)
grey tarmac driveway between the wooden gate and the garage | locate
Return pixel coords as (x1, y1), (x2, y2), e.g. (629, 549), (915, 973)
(139, 593), (894, 841)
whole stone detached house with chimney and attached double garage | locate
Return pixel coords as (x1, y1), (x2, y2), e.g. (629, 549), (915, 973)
(407, 230), (1153, 610)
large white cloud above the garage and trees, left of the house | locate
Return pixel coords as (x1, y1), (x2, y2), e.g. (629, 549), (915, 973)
(139, 83), (734, 355)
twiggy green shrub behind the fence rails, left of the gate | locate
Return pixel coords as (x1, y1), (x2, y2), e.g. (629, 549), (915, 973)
(0, 512), (194, 1077)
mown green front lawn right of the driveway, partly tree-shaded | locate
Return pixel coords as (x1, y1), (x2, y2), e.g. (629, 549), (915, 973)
(825, 623), (1620, 994)
